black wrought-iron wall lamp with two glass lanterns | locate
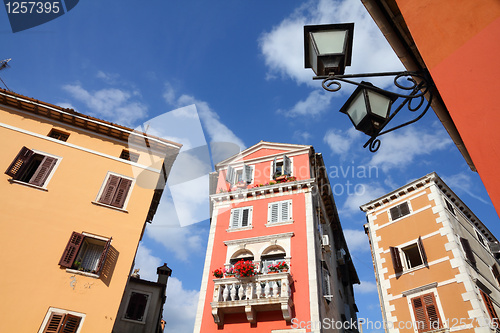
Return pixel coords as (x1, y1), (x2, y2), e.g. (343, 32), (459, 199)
(304, 23), (432, 152)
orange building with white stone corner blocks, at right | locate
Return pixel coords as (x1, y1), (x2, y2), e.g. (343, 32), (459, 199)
(361, 173), (500, 333)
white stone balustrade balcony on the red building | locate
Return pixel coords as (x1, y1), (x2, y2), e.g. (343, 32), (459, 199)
(210, 272), (293, 325)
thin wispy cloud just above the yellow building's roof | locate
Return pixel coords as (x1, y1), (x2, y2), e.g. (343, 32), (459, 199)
(63, 84), (147, 126)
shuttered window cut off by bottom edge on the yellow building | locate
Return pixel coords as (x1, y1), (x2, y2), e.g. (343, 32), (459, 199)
(38, 308), (84, 333)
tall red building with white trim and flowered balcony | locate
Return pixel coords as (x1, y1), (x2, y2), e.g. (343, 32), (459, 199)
(194, 141), (359, 333)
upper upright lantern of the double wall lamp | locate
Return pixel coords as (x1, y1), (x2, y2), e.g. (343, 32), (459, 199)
(304, 23), (354, 76)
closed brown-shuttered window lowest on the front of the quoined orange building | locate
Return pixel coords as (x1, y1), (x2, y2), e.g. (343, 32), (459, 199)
(411, 293), (442, 332)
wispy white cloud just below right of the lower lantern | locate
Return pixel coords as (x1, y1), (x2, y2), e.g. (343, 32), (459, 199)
(370, 126), (453, 172)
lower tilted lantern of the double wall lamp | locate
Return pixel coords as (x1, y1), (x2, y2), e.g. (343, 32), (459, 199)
(340, 82), (398, 136)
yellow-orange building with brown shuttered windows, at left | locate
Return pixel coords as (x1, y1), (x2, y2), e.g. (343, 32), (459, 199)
(0, 90), (180, 333)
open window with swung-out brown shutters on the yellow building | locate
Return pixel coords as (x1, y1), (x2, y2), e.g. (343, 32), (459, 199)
(59, 232), (111, 277)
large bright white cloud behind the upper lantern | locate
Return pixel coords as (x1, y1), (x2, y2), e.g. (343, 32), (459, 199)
(259, 0), (402, 86)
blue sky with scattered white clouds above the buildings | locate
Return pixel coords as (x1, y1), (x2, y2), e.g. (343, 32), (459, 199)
(0, 0), (500, 333)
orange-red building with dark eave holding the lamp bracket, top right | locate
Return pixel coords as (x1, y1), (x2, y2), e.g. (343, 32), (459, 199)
(361, 0), (500, 217)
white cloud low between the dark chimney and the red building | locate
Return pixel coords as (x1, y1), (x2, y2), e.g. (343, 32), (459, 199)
(163, 277), (200, 333)
